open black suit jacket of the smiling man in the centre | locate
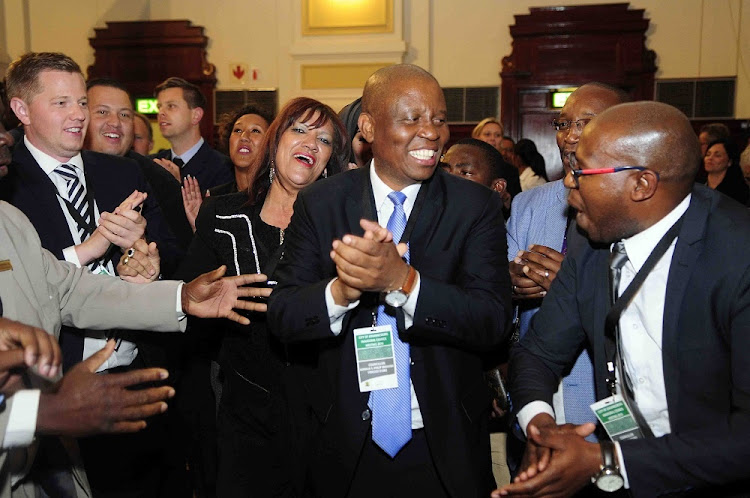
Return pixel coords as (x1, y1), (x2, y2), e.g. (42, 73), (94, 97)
(268, 168), (511, 497)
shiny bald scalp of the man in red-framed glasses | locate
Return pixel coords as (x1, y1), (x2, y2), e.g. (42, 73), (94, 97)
(582, 101), (701, 192)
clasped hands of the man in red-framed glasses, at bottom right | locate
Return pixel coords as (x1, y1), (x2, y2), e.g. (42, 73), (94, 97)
(491, 413), (602, 498)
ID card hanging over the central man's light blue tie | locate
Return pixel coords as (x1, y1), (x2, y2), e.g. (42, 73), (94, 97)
(354, 325), (398, 393)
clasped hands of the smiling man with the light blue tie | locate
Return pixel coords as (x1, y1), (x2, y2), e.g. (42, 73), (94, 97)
(330, 219), (409, 306)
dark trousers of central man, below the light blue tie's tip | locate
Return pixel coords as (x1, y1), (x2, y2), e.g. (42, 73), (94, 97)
(348, 429), (448, 498)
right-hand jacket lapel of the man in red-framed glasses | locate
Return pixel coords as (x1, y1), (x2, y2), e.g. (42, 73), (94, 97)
(662, 189), (710, 427)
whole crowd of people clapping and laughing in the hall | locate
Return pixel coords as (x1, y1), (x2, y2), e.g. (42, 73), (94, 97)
(0, 52), (750, 498)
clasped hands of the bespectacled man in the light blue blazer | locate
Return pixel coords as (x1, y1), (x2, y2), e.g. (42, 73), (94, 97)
(508, 244), (565, 299)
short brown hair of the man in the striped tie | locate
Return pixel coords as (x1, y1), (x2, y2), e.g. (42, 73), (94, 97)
(5, 52), (83, 103)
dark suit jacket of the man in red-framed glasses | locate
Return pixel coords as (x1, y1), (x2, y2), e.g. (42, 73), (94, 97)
(510, 185), (750, 497)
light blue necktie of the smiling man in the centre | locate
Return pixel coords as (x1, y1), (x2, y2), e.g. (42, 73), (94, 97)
(370, 192), (411, 458)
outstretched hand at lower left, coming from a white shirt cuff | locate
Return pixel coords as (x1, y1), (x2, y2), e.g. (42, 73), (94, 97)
(37, 340), (175, 437)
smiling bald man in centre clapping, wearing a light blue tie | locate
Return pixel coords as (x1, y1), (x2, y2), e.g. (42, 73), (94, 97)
(269, 65), (510, 497)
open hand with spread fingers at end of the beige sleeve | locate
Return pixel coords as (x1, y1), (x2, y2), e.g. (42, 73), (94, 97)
(182, 265), (271, 325)
